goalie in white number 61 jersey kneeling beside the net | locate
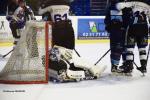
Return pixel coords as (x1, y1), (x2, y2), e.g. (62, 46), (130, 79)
(39, 0), (106, 81)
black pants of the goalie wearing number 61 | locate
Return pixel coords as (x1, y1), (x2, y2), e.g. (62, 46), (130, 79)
(52, 20), (75, 49)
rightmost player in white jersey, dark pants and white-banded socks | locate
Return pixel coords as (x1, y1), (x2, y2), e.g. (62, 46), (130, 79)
(117, 0), (150, 73)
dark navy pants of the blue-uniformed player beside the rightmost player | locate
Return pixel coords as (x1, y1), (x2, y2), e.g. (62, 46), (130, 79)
(110, 28), (125, 66)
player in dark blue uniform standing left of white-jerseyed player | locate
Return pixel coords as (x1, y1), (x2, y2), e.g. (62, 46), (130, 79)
(104, 0), (125, 73)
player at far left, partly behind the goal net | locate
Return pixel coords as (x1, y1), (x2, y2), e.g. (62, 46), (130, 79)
(6, 0), (35, 45)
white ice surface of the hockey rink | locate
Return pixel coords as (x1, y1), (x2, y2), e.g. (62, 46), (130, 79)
(0, 43), (150, 100)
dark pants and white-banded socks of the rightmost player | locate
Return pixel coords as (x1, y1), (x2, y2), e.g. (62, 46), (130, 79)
(126, 24), (148, 66)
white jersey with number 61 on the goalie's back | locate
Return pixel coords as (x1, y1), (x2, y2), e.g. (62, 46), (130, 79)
(39, 5), (70, 22)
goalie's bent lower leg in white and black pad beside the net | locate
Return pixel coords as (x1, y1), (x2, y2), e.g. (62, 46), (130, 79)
(49, 45), (85, 81)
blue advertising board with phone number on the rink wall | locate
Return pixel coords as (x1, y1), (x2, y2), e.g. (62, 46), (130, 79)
(78, 18), (108, 39)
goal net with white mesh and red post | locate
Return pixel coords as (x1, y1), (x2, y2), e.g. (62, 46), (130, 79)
(0, 21), (51, 84)
